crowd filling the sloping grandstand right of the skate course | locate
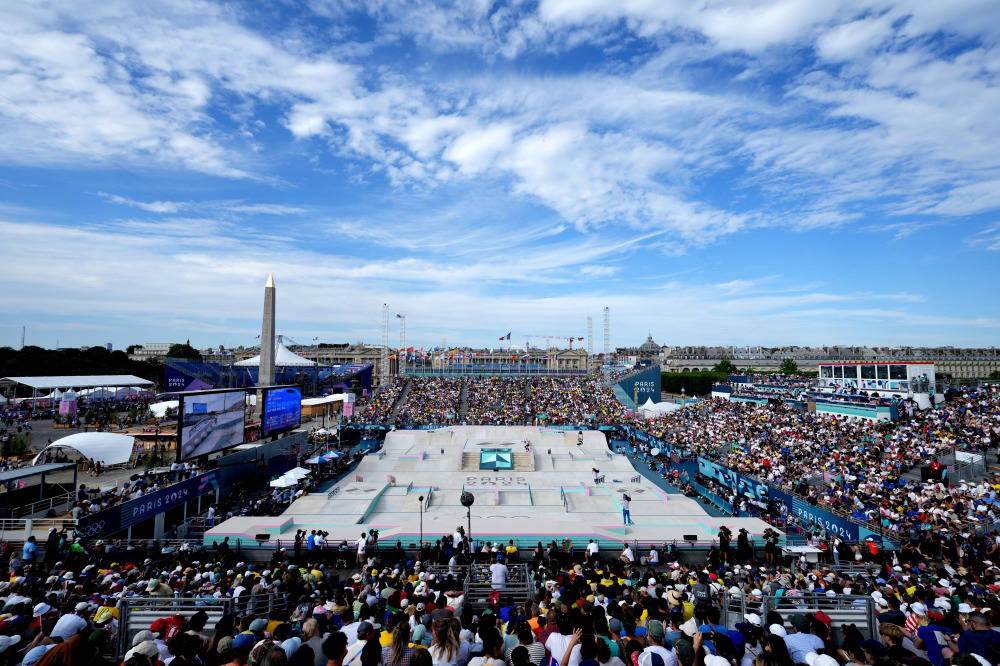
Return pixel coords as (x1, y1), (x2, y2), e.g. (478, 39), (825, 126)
(638, 388), (1000, 533)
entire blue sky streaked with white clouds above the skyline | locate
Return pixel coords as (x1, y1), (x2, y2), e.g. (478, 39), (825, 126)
(0, 0), (1000, 349)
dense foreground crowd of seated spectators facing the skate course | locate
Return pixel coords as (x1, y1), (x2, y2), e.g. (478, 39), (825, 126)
(9, 531), (1000, 666)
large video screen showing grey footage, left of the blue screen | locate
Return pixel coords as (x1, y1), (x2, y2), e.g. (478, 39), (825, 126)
(177, 391), (247, 460)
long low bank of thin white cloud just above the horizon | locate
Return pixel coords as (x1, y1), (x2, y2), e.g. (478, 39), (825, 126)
(0, 218), (1000, 345)
